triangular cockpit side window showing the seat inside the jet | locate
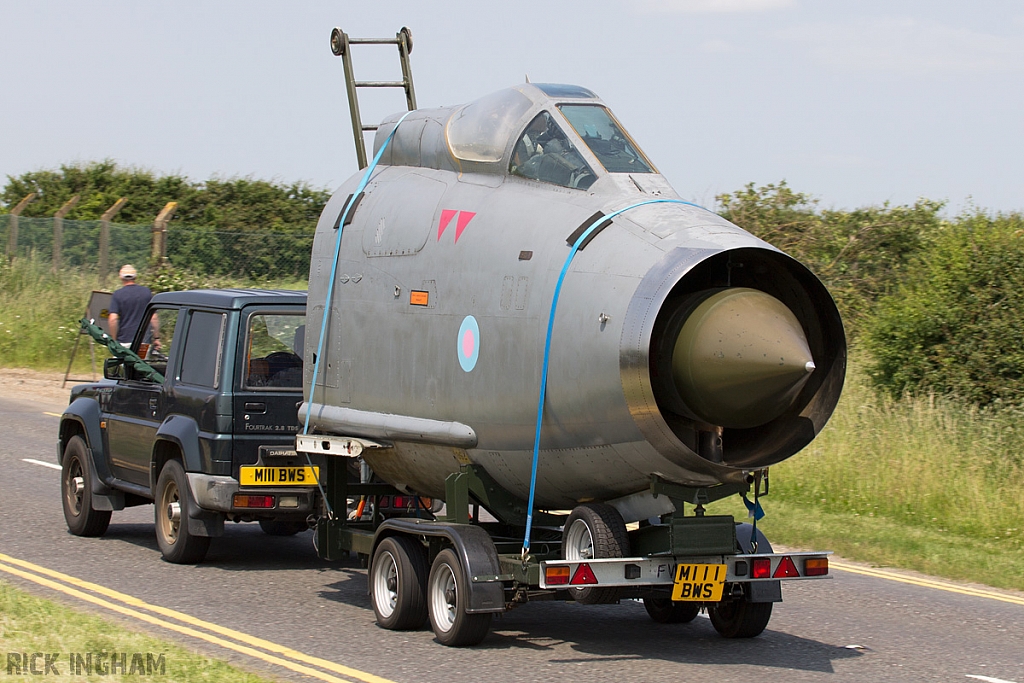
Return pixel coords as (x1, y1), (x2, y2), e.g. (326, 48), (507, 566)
(509, 112), (595, 189)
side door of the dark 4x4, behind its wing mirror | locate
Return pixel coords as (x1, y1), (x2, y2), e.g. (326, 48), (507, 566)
(103, 305), (179, 487)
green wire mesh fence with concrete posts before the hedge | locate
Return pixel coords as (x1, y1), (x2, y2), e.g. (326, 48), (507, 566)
(0, 215), (313, 280)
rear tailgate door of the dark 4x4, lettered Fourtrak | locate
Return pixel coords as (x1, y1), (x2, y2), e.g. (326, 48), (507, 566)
(232, 305), (305, 485)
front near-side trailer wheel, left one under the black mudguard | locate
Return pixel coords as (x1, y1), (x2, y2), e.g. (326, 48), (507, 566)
(370, 536), (427, 631)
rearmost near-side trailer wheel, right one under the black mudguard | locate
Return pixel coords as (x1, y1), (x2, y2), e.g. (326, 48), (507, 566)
(427, 548), (492, 647)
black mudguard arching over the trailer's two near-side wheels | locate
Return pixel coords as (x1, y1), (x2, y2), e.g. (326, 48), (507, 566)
(370, 518), (505, 614)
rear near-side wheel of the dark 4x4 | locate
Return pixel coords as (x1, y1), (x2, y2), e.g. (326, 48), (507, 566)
(155, 460), (210, 564)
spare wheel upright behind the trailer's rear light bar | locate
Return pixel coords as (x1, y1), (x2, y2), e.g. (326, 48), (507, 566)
(562, 503), (630, 605)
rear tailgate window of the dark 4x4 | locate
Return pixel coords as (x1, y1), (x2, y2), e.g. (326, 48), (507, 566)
(243, 313), (306, 389)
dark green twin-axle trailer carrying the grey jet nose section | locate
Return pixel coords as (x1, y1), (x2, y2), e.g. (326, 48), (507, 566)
(296, 434), (830, 646)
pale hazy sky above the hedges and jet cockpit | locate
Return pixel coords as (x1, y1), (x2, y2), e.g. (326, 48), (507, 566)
(0, 0), (1024, 214)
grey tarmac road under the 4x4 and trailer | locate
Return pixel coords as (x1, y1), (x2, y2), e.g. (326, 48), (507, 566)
(0, 394), (1024, 683)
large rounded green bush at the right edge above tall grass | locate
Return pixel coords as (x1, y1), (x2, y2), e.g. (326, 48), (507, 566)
(865, 212), (1024, 405)
